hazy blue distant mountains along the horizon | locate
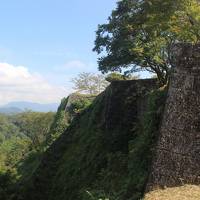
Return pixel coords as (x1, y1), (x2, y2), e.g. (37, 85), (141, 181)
(0, 101), (59, 113)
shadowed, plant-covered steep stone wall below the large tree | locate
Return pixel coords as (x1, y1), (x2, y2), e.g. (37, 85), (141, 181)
(21, 80), (165, 200)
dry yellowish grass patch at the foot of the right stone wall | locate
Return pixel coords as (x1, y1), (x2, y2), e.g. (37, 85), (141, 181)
(144, 185), (200, 200)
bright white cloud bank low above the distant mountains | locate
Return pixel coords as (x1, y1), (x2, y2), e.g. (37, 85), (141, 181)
(0, 63), (69, 105)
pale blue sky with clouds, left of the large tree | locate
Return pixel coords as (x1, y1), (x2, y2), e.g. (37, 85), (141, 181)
(0, 0), (117, 103)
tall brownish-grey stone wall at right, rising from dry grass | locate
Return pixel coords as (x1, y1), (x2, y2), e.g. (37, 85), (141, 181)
(147, 44), (200, 190)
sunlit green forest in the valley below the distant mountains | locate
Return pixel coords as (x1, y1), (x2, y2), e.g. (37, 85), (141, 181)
(0, 111), (54, 199)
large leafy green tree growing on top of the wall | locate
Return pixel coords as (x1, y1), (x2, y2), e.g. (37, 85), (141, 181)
(93, 0), (200, 85)
